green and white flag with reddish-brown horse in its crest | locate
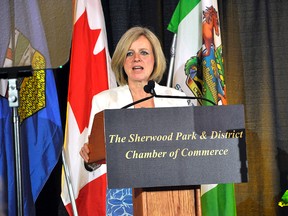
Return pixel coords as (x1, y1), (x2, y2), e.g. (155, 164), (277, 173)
(168, 0), (236, 216)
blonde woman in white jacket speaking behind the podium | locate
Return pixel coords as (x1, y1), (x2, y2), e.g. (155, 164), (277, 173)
(80, 27), (188, 215)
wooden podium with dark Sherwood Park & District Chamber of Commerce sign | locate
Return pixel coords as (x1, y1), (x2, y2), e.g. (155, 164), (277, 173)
(89, 105), (248, 216)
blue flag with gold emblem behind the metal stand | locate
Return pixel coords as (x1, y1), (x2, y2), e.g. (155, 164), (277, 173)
(0, 0), (63, 216)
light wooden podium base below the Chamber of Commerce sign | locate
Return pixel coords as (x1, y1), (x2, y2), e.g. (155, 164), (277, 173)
(133, 186), (202, 216)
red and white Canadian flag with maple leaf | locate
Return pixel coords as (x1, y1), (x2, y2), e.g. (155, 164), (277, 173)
(61, 0), (116, 215)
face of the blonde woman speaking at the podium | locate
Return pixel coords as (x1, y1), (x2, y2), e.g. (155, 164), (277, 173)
(124, 36), (155, 83)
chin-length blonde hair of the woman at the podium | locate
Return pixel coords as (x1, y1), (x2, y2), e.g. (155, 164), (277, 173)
(111, 26), (166, 86)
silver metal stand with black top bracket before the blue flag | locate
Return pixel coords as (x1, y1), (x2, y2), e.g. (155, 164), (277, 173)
(0, 66), (32, 216)
